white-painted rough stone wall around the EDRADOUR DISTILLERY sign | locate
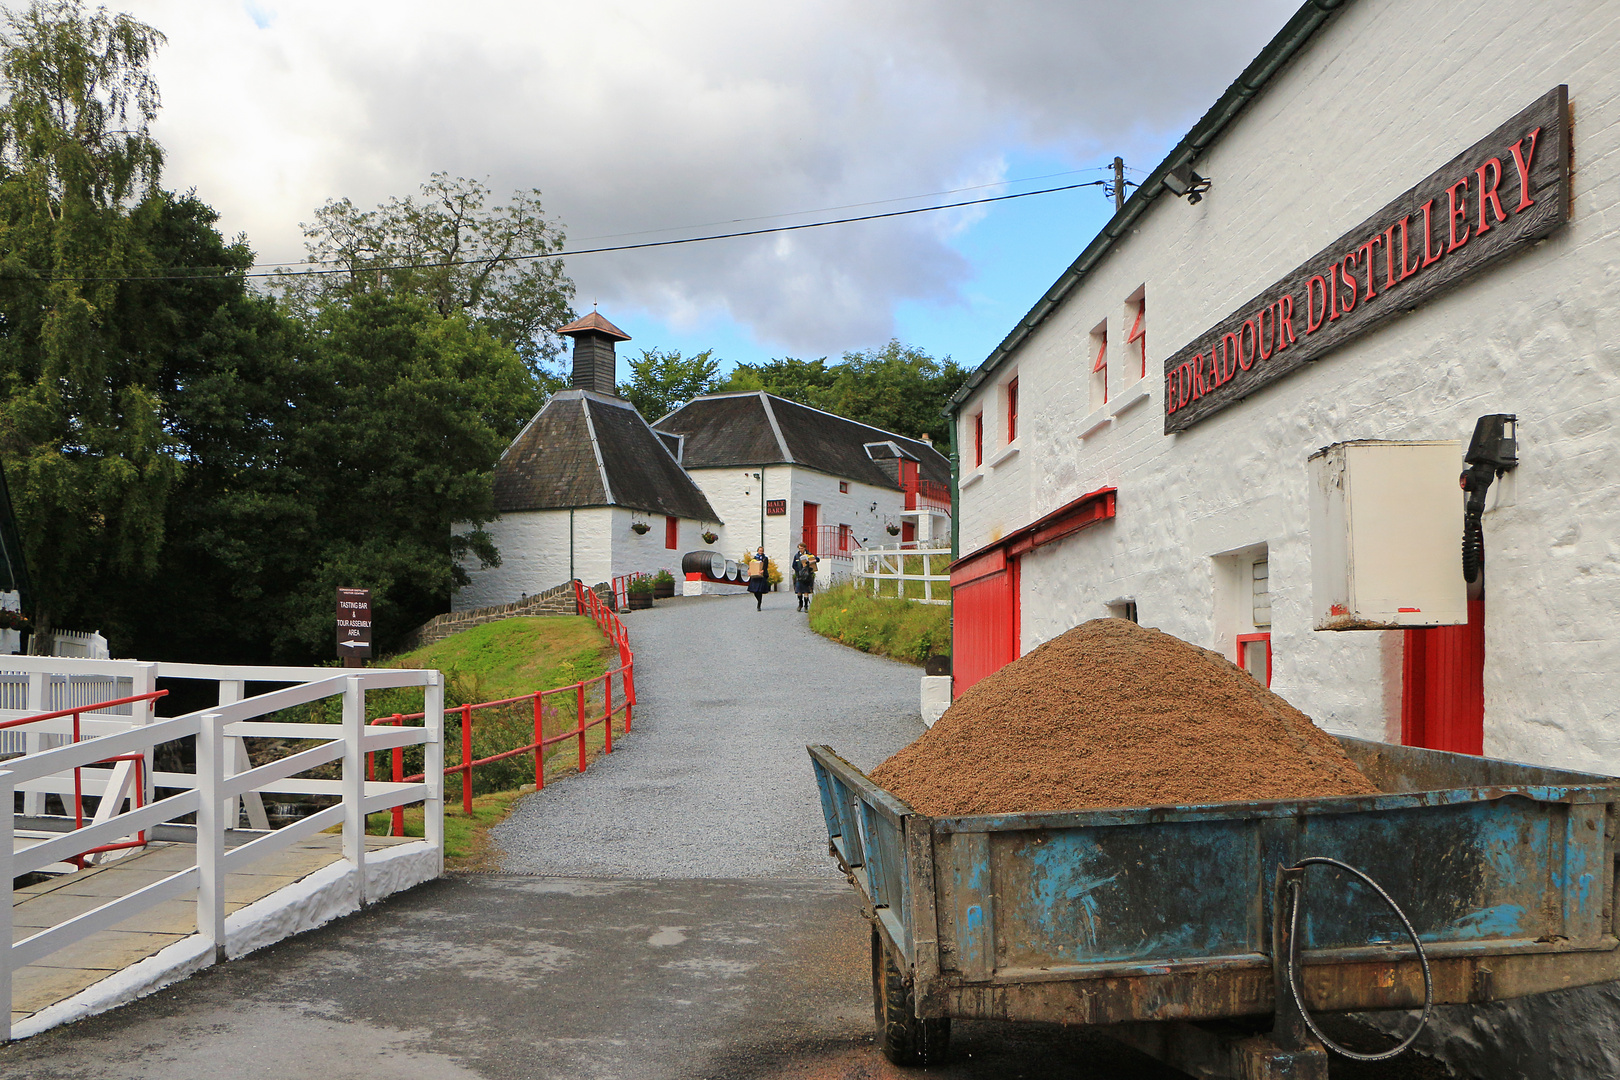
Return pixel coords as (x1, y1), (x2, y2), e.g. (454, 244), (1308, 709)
(959, 0), (1620, 772)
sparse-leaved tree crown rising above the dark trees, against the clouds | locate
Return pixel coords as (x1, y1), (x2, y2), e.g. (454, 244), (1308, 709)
(277, 173), (573, 381)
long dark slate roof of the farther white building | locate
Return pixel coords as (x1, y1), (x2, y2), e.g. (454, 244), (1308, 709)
(658, 392), (951, 487)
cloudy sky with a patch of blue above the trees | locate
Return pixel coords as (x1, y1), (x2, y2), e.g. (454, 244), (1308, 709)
(109, 0), (1298, 374)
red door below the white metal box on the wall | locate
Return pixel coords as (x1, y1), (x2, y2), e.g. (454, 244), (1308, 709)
(1401, 599), (1486, 755)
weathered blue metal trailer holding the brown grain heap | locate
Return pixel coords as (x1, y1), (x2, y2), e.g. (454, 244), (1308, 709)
(808, 738), (1620, 1077)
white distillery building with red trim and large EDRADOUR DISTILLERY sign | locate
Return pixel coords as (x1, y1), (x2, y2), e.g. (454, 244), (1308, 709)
(953, 0), (1620, 1077)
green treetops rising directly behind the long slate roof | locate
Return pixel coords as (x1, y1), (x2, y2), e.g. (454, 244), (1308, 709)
(719, 340), (967, 440)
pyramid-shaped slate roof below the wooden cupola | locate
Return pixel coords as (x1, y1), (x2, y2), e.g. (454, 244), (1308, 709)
(494, 390), (721, 525)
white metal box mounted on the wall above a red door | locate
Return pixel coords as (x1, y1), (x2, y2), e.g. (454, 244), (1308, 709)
(1309, 440), (1468, 630)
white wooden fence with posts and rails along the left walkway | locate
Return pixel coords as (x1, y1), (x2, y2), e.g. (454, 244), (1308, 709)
(0, 656), (444, 1041)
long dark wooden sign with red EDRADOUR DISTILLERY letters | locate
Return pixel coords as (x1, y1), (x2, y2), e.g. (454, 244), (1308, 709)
(1165, 86), (1570, 434)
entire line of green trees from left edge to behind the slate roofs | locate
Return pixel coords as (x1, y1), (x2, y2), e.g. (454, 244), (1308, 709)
(0, 0), (962, 662)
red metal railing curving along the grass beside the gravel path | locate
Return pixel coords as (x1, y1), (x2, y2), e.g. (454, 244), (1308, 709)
(379, 581), (635, 836)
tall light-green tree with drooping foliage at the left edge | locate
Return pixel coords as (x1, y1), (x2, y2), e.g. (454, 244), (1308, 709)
(0, 0), (181, 628)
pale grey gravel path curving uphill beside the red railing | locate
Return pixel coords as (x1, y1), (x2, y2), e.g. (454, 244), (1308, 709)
(492, 593), (923, 878)
